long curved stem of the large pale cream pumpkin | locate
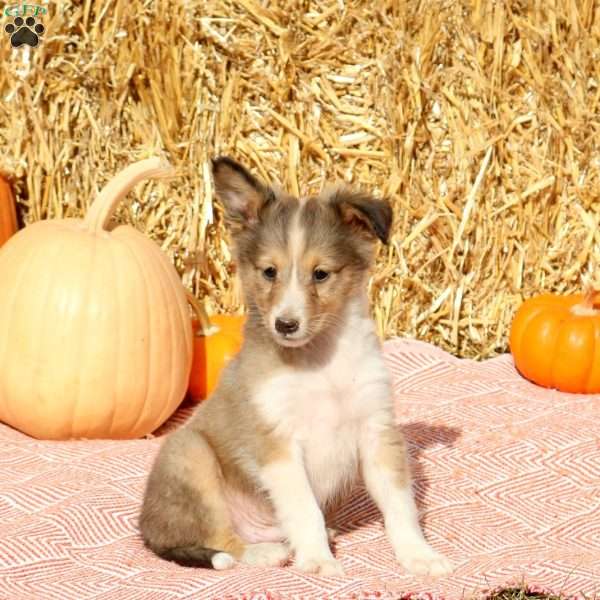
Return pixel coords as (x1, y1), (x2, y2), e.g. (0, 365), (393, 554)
(84, 157), (175, 233)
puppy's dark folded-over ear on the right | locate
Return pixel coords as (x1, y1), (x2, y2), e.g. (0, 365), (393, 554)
(330, 188), (392, 244)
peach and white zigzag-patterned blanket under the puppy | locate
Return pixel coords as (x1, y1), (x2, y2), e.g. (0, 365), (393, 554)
(0, 340), (600, 600)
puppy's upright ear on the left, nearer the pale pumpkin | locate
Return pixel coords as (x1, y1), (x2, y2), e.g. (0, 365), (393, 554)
(212, 156), (273, 227)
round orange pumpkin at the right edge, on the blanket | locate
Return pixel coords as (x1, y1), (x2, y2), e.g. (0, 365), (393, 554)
(510, 290), (600, 394)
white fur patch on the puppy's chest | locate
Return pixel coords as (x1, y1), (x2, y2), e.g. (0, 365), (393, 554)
(255, 316), (390, 506)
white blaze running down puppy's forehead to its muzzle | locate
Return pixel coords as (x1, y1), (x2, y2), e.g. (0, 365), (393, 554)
(271, 211), (307, 345)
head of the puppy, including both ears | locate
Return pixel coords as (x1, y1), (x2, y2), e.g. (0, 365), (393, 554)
(213, 158), (392, 347)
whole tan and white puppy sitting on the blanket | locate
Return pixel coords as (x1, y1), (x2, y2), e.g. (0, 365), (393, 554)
(140, 158), (451, 575)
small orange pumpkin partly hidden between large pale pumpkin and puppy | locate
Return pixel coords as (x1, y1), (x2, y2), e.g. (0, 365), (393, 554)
(188, 292), (246, 402)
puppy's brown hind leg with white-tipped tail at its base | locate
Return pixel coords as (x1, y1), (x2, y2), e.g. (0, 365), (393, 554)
(140, 427), (244, 569)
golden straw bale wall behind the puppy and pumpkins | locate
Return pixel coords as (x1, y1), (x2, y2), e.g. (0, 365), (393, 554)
(0, 0), (600, 357)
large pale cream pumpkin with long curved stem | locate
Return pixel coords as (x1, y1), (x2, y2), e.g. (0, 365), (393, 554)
(0, 159), (192, 439)
